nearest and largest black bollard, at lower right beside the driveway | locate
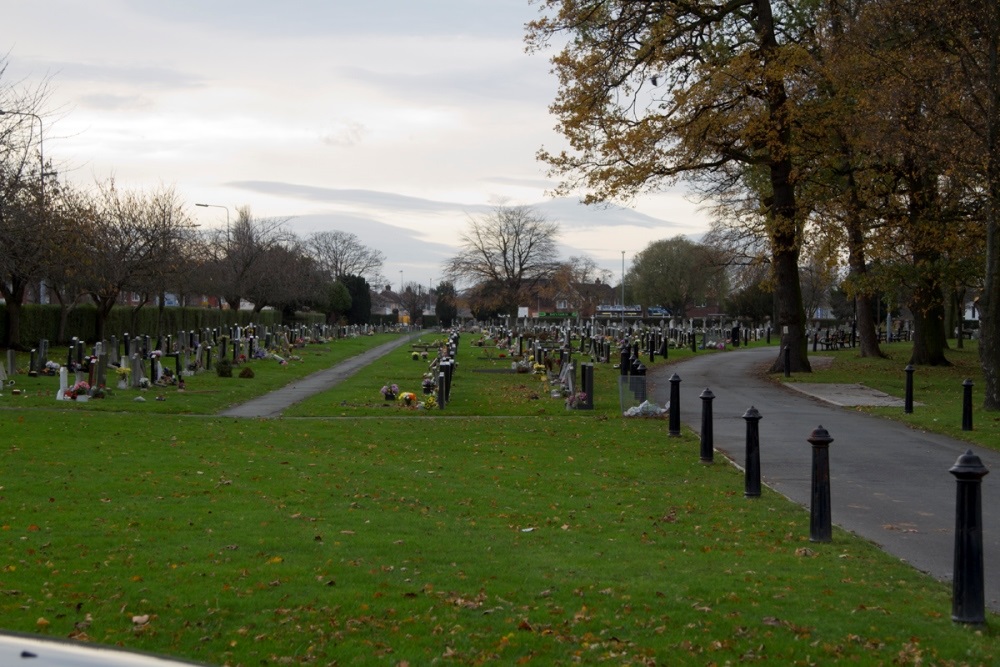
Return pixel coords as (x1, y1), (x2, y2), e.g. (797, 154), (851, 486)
(948, 449), (989, 623)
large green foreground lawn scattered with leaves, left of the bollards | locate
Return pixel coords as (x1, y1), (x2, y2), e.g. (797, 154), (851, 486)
(0, 339), (1000, 665)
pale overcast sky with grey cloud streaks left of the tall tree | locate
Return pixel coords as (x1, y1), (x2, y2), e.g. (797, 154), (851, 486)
(0, 0), (707, 288)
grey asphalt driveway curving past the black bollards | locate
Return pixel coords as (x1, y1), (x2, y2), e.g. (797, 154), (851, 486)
(649, 346), (1000, 611)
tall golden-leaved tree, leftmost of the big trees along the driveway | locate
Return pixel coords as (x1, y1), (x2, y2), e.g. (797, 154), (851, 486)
(527, 0), (810, 370)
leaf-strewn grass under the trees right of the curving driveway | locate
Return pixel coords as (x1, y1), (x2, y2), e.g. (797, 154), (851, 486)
(775, 341), (1000, 449)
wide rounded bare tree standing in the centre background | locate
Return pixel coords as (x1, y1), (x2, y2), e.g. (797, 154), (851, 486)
(445, 203), (559, 316)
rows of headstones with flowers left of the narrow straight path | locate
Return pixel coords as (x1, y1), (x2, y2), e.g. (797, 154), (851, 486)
(0, 324), (402, 401)
